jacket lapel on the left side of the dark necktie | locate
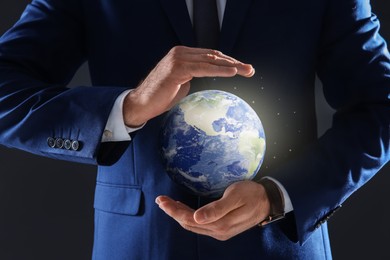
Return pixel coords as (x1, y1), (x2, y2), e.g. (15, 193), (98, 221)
(160, 0), (196, 46)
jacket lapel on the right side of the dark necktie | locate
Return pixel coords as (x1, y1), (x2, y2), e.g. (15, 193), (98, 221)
(219, 0), (252, 54)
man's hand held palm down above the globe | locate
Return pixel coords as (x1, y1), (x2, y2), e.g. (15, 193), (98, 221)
(123, 46), (255, 126)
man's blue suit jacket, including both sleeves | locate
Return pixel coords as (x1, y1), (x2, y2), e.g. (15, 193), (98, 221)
(0, 0), (390, 259)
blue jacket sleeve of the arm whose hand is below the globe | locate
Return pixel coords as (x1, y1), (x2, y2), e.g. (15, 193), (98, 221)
(274, 0), (390, 243)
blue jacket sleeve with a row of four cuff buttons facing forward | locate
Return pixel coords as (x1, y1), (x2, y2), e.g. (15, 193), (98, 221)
(0, 0), (129, 164)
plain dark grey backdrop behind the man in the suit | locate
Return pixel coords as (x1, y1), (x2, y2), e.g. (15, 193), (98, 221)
(0, 0), (390, 260)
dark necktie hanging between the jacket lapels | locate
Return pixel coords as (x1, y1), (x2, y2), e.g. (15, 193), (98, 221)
(193, 0), (219, 49)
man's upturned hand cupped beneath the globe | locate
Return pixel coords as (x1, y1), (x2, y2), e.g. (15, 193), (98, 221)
(156, 181), (270, 240)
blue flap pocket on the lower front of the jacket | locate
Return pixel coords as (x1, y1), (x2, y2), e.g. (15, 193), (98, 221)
(94, 182), (142, 216)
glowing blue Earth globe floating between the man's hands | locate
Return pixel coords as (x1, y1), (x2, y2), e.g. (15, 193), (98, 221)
(161, 90), (266, 197)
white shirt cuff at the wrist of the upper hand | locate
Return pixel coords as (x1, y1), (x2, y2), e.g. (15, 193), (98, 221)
(101, 89), (145, 142)
